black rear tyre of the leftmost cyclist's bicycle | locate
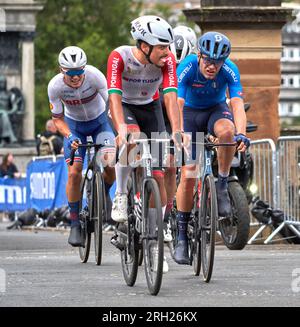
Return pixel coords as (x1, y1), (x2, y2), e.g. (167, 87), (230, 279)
(79, 177), (92, 263)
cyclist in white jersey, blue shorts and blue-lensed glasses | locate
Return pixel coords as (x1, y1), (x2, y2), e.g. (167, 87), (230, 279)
(48, 46), (115, 246)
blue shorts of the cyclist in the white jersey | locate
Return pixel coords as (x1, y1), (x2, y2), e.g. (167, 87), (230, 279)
(64, 112), (115, 163)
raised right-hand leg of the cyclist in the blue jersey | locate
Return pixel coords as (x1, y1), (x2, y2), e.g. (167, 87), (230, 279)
(208, 103), (235, 217)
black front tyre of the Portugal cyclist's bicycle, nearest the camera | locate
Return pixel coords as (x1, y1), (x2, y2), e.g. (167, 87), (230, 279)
(142, 178), (164, 295)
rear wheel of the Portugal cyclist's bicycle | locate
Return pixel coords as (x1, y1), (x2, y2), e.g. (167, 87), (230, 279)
(118, 190), (139, 286)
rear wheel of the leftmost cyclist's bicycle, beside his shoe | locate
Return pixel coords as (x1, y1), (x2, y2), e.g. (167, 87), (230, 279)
(79, 177), (92, 263)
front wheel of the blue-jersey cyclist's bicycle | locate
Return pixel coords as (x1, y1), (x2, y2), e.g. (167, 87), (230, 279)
(199, 175), (218, 283)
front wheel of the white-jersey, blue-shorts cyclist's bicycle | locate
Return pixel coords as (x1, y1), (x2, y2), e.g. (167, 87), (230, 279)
(93, 172), (106, 266)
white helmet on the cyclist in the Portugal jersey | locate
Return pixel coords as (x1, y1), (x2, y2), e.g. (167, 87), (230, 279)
(131, 15), (174, 46)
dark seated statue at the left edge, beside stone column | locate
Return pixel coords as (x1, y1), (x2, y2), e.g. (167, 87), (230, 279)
(0, 75), (24, 146)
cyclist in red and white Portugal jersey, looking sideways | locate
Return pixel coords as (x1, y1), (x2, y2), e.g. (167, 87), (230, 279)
(107, 16), (181, 272)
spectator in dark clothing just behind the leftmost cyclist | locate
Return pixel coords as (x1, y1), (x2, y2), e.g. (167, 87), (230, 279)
(36, 119), (63, 156)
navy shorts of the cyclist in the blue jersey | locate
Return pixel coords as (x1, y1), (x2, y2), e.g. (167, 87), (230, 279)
(183, 102), (234, 160)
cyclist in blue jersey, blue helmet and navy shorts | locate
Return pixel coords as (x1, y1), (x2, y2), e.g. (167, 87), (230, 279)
(174, 32), (250, 264)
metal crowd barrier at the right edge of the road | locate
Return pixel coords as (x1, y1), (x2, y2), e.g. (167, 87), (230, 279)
(248, 136), (300, 244)
